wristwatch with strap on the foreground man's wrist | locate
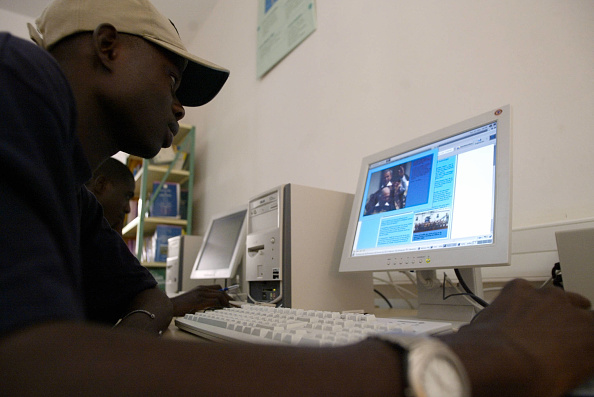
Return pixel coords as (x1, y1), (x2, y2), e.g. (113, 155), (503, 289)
(374, 333), (470, 397)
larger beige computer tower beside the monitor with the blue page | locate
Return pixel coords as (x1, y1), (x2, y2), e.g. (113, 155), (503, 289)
(245, 184), (373, 312)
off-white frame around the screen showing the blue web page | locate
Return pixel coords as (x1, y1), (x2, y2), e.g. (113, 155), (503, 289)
(339, 105), (512, 272)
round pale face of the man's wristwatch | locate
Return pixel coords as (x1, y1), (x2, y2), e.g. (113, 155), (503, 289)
(421, 356), (464, 397)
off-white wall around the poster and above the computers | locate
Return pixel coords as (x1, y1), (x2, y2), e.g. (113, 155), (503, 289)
(186, 0), (594, 235)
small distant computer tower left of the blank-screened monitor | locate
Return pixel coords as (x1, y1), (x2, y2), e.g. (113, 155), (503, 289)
(165, 235), (204, 294)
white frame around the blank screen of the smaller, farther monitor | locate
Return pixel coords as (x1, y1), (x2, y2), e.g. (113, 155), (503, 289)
(190, 205), (247, 280)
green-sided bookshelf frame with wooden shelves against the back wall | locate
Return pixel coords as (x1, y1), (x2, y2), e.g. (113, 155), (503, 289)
(122, 125), (195, 269)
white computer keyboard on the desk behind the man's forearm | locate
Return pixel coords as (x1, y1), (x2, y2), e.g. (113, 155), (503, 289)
(175, 304), (452, 346)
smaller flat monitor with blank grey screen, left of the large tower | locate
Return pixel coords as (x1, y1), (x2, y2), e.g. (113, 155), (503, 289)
(190, 207), (247, 279)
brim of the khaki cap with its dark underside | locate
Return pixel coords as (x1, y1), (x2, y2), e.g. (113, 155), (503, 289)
(144, 36), (229, 107)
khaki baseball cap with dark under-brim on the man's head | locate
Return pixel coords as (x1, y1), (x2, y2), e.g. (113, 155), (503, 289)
(28, 0), (229, 106)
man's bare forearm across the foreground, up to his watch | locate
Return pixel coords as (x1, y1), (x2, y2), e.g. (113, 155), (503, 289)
(0, 323), (401, 396)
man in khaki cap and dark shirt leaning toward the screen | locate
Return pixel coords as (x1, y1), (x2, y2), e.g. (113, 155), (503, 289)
(0, 0), (594, 396)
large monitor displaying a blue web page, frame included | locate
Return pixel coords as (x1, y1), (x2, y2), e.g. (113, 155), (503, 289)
(340, 106), (511, 271)
